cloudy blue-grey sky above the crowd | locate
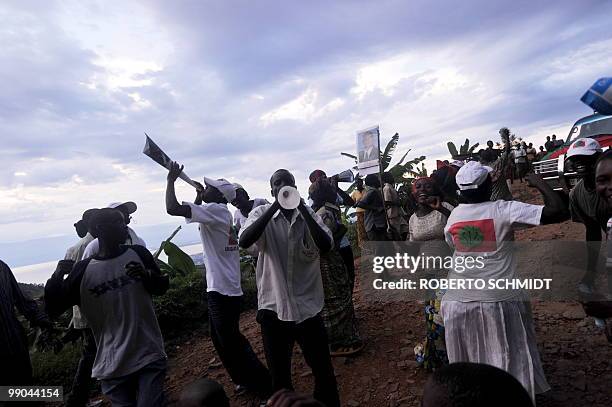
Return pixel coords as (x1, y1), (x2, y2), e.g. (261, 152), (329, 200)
(0, 0), (612, 274)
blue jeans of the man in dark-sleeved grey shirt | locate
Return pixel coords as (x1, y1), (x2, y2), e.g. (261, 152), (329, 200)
(100, 359), (167, 407)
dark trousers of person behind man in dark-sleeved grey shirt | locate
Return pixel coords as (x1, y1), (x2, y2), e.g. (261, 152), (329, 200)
(66, 328), (97, 407)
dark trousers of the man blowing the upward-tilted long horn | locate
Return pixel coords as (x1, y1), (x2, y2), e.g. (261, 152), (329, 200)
(206, 291), (272, 398)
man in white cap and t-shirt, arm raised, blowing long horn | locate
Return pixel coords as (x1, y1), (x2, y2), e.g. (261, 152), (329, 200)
(166, 162), (271, 398)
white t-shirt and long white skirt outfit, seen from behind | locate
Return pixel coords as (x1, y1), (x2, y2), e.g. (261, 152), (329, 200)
(441, 200), (550, 402)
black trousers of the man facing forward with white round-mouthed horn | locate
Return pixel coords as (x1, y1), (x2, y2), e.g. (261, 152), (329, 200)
(257, 310), (340, 407)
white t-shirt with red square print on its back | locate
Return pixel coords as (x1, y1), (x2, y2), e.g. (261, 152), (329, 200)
(444, 200), (544, 302)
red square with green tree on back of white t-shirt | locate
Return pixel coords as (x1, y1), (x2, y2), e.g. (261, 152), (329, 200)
(448, 219), (497, 252)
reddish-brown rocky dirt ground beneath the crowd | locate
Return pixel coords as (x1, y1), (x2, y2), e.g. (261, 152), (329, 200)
(167, 184), (612, 407)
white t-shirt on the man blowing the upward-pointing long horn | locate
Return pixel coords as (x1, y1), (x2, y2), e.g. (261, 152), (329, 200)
(183, 202), (242, 296)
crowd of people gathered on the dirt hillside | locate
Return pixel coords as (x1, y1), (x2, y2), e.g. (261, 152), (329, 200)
(0, 128), (612, 407)
